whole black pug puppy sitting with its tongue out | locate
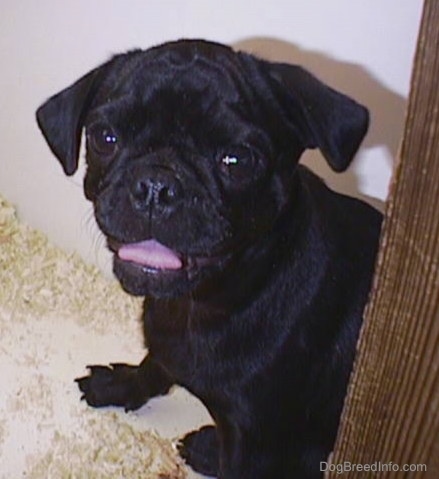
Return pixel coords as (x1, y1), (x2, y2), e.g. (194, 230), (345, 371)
(37, 40), (381, 479)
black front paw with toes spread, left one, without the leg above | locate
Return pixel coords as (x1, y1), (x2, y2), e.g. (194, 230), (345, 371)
(75, 364), (148, 411)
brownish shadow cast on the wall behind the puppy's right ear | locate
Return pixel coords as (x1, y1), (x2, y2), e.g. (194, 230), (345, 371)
(234, 38), (407, 209)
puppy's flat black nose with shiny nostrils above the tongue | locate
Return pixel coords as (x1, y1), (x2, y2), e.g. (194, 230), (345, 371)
(130, 167), (183, 210)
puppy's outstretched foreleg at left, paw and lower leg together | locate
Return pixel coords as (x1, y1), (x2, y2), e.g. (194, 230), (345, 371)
(75, 356), (173, 411)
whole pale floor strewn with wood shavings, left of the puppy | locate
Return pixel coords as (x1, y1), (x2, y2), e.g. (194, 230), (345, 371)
(0, 197), (187, 479)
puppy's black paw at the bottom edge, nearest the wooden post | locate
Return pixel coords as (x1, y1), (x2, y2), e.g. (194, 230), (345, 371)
(178, 426), (219, 476)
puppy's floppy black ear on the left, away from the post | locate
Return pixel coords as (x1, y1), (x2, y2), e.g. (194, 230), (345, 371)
(36, 68), (101, 175)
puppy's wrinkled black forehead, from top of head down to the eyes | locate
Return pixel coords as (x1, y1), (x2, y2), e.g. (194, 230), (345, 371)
(86, 47), (264, 149)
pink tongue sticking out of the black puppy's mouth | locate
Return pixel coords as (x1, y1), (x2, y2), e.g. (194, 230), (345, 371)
(118, 240), (183, 270)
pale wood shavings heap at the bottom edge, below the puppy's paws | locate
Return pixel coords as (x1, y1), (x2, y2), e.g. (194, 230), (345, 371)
(26, 412), (186, 479)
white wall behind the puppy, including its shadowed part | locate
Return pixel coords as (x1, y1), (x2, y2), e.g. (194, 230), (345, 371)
(0, 0), (422, 274)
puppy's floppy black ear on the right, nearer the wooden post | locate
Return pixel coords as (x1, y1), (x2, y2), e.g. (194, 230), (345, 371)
(269, 63), (369, 171)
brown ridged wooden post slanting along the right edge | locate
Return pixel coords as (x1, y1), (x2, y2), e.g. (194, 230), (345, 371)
(327, 0), (439, 479)
